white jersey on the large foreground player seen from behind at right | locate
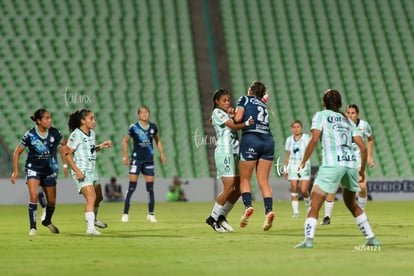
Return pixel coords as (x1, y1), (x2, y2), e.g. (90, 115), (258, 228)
(311, 109), (361, 168)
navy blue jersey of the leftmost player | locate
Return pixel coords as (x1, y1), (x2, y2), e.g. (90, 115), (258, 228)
(20, 127), (62, 174)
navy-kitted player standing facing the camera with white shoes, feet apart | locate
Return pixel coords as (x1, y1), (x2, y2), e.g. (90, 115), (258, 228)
(121, 106), (165, 222)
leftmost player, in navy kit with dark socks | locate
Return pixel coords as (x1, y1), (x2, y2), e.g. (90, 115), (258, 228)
(11, 108), (63, 235)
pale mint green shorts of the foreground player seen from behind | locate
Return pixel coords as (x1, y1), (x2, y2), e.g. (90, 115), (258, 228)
(315, 166), (361, 194)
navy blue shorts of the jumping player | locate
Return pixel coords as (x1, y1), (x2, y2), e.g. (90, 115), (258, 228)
(240, 132), (275, 161)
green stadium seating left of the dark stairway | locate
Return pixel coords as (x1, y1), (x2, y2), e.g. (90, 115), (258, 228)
(0, 0), (208, 177)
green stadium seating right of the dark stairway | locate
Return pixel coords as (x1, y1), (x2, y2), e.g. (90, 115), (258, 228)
(221, 0), (414, 178)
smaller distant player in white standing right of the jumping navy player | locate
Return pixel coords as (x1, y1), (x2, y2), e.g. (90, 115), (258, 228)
(283, 120), (311, 218)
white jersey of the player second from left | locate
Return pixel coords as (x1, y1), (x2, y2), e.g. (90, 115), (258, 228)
(67, 128), (96, 171)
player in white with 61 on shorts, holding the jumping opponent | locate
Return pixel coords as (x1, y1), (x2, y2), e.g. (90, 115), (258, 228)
(206, 89), (254, 232)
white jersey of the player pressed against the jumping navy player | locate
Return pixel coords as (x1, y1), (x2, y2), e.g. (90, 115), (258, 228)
(211, 108), (239, 154)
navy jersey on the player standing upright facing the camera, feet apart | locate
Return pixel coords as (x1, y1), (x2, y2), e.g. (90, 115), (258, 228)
(128, 122), (158, 161)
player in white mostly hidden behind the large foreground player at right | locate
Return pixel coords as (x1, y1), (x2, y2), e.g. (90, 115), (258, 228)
(321, 104), (374, 225)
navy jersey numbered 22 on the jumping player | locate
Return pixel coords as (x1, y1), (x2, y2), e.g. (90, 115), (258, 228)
(237, 96), (272, 135)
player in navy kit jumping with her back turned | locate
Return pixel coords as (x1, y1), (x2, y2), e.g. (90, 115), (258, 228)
(234, 81), (275, 231)
